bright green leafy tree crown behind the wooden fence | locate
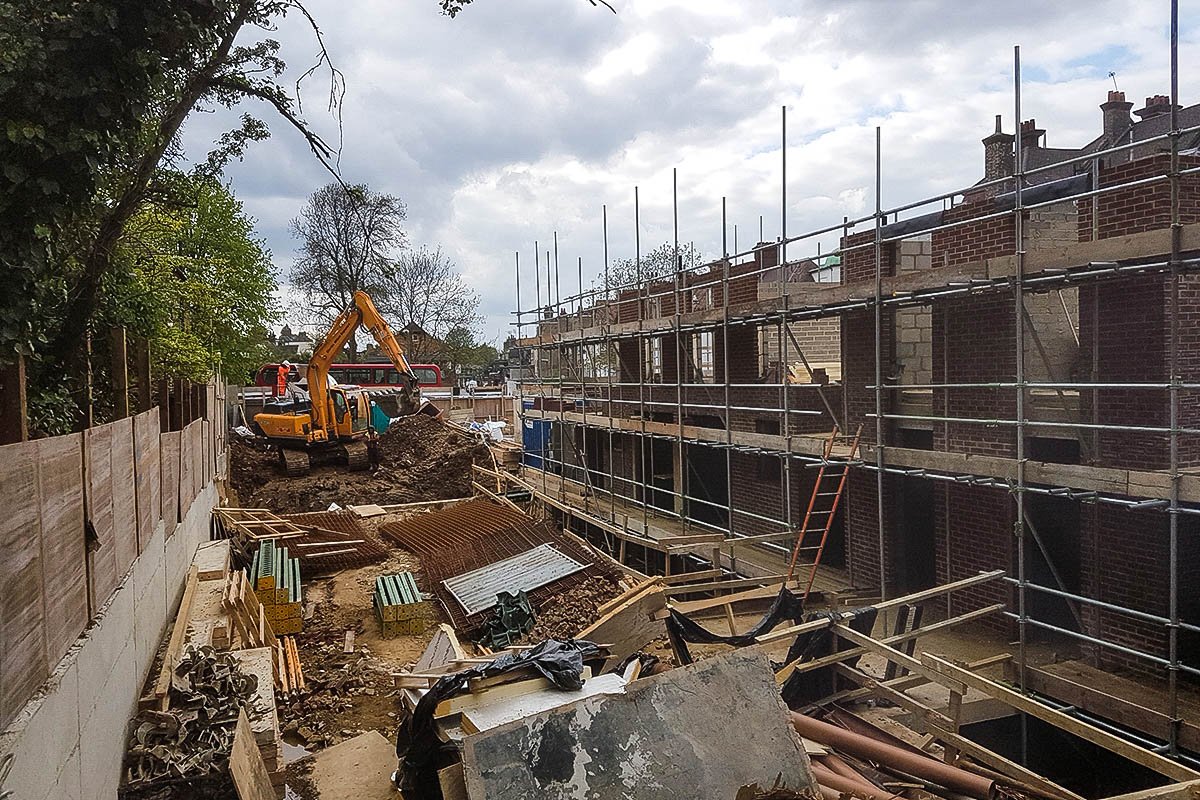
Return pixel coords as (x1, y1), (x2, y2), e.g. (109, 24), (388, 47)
(103, 176), (278, 380)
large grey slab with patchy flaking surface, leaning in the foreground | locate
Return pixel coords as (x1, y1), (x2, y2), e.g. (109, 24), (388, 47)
(463, 650), (815, 800)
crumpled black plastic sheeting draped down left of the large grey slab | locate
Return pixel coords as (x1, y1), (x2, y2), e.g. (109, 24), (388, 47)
(396, 639), (600, 800)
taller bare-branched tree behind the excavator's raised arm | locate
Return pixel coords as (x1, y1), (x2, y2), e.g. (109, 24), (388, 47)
(292, 184), (407, 361)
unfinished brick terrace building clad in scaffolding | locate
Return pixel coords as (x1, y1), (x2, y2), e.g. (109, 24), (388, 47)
(516, 54), (1200, 766)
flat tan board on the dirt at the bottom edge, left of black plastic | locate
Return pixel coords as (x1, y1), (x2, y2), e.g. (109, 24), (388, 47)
(296, 730), (400, 800)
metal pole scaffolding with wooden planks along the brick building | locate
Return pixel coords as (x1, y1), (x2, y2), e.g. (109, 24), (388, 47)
(515, 2), (1200, 765)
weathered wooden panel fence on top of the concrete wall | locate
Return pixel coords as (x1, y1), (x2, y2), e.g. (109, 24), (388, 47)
(0, 386), (226, 730)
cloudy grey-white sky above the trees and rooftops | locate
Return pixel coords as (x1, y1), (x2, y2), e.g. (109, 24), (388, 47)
(185, 0), (1200, 339)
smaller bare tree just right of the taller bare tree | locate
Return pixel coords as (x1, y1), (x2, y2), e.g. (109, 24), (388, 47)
(383, 247), (482, 361)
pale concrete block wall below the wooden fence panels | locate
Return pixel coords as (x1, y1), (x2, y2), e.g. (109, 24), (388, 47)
(0, 481), (217, 800)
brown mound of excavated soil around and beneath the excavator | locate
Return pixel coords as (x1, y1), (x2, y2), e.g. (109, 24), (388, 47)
(229, 415), (491, 513)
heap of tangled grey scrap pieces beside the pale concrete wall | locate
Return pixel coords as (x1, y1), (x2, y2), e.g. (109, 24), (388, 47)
(121, 646), (258, 800)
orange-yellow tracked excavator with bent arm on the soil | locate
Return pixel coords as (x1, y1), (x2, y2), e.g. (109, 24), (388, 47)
(254, 291), (421, 477)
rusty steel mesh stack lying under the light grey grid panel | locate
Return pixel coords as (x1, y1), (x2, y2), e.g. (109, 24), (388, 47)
(379, 499), (620, 636)
